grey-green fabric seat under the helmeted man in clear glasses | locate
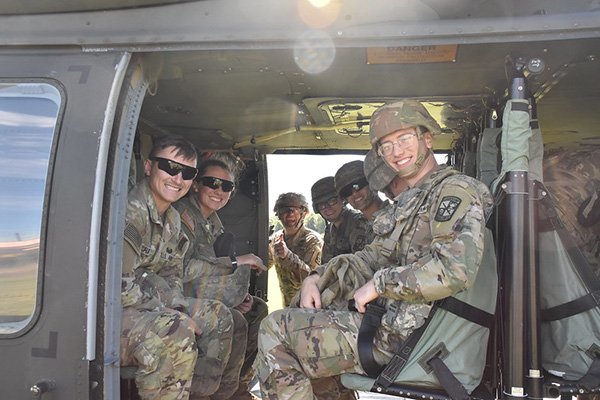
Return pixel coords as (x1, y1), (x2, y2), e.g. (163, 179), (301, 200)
(342, 229), (498, 393)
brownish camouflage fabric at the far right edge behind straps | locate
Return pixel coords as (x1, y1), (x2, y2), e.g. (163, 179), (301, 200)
(544, 148), (600, 277)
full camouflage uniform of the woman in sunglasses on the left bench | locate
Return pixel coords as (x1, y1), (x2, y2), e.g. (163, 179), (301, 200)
(175, 195), (268, 399)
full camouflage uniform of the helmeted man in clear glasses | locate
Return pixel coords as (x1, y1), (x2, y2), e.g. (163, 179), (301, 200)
(256, 167), (493, 399)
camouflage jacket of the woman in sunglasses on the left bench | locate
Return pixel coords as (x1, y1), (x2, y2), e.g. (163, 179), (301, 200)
(175, 195), (250, 307)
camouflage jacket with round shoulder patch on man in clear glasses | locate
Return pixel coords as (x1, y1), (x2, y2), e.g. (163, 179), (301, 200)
(317, 166), (494, 351)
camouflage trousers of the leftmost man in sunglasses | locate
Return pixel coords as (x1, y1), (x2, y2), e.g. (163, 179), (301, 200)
(120, 308), (198, 400)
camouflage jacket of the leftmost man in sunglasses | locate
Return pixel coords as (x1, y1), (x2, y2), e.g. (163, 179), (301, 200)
(121, 179), (188, 309)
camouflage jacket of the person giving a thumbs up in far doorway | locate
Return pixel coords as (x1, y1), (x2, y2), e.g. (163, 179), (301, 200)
(269, 225), (323, 306)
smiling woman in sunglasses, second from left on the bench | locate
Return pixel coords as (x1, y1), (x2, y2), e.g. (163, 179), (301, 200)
(175, 158), (268, 399)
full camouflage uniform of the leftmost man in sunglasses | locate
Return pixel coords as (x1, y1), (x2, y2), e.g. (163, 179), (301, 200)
(120, 180), (198, 399)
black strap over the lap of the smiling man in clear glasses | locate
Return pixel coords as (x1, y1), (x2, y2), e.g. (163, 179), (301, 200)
(357, 303), (385, 378)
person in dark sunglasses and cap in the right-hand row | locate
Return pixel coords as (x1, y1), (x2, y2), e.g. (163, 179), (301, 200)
(334, 160), (389, 222)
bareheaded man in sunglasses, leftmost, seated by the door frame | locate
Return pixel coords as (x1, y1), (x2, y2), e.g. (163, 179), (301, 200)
(120, 138), (200, 399)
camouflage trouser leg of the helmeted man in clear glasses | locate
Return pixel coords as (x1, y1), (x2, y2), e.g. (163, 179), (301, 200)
(255, 308), (364, 400)
